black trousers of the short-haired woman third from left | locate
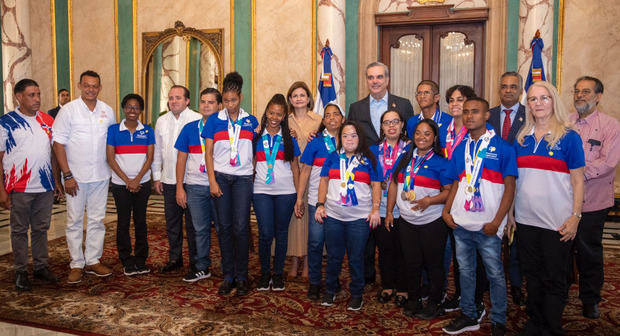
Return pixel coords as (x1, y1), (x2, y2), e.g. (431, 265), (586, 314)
(110, 181), (151, 266)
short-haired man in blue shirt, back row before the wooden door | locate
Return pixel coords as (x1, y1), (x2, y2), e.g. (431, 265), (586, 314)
(407, 80), (452, 148)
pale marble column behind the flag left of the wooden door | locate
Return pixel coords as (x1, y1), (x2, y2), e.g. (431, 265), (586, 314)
(313, 0), (346, 108)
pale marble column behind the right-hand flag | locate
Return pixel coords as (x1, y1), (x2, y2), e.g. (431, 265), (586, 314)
(517, 0), (554, 89)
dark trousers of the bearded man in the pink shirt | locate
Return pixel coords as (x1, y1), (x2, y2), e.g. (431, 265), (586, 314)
(569, 209), (609, 304)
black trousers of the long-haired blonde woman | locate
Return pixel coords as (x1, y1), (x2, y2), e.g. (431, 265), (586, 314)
(517, 223), (573, 335)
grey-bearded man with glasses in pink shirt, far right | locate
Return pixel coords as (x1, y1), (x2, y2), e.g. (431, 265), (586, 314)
(570, 76), (620, 319)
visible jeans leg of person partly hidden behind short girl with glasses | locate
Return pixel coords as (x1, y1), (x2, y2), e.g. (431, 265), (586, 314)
(308, 204), (325, 285)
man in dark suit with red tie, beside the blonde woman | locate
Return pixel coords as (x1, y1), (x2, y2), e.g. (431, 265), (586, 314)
(489, 72), (525, 306)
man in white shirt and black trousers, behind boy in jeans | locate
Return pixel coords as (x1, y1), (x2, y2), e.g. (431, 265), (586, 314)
(152, 85), (201, 273)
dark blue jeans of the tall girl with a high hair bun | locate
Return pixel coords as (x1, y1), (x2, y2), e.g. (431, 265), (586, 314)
(215, 172), (254, 281)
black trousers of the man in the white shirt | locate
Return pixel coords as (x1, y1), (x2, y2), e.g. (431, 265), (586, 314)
(162, 183), (197, 266)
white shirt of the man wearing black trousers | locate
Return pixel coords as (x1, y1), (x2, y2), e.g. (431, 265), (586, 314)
(151, 107), (202, 184)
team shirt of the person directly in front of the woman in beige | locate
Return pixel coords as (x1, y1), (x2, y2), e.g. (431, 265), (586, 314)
(299, 133), (336, 206)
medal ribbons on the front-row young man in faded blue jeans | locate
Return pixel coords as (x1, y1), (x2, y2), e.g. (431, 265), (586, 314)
(465, 130), (495, 212)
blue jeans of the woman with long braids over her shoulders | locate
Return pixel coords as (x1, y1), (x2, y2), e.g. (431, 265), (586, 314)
(254, 194), (297, 275)
